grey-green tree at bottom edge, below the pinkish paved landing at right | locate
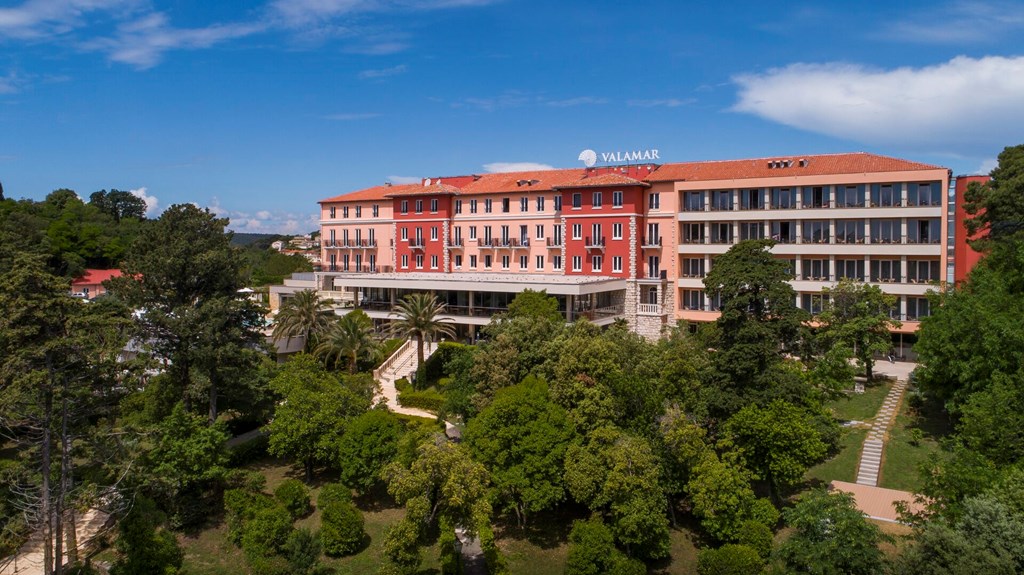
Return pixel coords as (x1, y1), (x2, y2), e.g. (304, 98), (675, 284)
(778, 490), (889, 575)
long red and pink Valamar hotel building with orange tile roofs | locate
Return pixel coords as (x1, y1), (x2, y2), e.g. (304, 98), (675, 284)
(299, 153), (952, 344)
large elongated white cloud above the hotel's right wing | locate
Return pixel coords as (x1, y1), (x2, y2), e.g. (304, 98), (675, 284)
(733, 56), (1024, 154)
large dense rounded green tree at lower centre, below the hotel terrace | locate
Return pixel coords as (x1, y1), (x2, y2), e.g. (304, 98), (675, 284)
(465, 378), (573, 526)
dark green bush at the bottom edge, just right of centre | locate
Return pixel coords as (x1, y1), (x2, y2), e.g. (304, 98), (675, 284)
(565, 518), (647, 575)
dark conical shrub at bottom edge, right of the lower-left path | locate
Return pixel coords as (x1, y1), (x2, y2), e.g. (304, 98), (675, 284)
(111, 497), (183, 575)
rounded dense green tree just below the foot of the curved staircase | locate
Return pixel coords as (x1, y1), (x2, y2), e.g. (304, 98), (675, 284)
(338, 409), (402, 493)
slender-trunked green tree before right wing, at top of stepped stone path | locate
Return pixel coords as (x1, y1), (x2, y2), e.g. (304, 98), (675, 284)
(816, 278), (901, 380)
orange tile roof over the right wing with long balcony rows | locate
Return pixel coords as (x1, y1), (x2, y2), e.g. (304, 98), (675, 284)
(646, 151), (942, 182)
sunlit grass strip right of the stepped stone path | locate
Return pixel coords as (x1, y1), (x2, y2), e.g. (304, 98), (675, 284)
(879, 388), (952, 491)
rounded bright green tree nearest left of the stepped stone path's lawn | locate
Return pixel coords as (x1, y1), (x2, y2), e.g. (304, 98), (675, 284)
(725, 400), (828, 494)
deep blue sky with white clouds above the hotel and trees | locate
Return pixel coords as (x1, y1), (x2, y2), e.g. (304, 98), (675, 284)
(0, 0), (1024, 232)
